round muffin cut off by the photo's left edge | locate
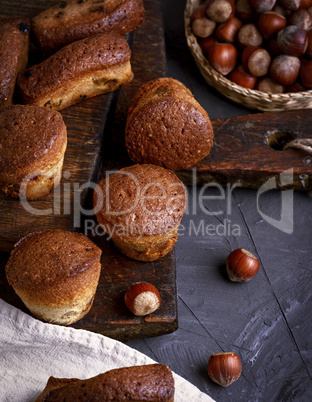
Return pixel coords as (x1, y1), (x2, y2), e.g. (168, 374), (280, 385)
(0, 105), (67, 200)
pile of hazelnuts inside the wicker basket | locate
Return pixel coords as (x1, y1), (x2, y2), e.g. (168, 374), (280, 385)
(191, 0), (312, 93)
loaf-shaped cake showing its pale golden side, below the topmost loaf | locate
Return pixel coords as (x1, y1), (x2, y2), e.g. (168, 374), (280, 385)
(17, 34), (133, 110)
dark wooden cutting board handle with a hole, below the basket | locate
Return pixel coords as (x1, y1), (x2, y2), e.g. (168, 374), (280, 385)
(178, 110), (312, 191)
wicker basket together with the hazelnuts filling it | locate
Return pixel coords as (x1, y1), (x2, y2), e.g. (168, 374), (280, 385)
(185, 0), (312, 111)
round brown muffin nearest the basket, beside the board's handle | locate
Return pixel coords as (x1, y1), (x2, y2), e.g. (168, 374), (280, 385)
(126, 78), (213, 170)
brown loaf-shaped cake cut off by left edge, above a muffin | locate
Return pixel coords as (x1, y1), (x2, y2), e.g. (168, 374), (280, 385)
(0, 18), (30, 108)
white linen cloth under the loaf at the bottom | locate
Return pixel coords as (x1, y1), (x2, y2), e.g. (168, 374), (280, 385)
(0, 299), (213, 402)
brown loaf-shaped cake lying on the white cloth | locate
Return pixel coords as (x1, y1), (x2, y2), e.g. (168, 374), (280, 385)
(35, 364), (174, 402)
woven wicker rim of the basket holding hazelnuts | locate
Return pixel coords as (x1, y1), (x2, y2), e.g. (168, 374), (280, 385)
(184, 0), (312, 111)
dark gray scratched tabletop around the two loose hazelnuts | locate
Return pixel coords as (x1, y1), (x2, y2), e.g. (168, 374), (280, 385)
(128, 0), (312, 402)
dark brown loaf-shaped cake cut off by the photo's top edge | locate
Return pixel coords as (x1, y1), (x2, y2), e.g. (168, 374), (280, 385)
(32, 0), (145, 55)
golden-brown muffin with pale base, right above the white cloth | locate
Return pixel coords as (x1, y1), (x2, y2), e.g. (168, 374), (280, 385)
(5, 229), (102, 325)
